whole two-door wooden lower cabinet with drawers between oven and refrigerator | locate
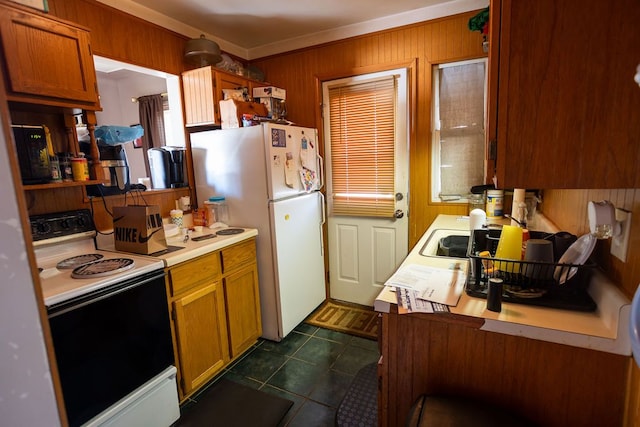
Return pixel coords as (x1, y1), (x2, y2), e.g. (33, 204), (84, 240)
(167, 238), (262, 401)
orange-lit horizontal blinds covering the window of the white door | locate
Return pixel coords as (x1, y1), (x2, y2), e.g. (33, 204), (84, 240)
(329, 76), (396, 217)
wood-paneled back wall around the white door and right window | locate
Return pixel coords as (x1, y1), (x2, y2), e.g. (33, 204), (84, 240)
(252, 12), (486, 247)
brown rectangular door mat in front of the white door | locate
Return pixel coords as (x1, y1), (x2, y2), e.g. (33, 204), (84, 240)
(305, 300), (378, 340)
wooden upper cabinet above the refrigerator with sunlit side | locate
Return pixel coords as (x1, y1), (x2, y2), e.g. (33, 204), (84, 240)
(182, 66), (260, 126)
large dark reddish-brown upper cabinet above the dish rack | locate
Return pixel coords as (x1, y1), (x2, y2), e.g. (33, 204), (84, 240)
(487, 0), (640, 188)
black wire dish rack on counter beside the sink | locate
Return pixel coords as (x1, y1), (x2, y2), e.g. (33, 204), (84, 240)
(465, 229), (597, 312)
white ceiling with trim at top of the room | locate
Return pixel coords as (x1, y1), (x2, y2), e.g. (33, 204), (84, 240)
(99, 0), (489, 59)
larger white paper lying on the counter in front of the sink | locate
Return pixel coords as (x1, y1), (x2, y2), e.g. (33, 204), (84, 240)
(385, 264), (466, 306)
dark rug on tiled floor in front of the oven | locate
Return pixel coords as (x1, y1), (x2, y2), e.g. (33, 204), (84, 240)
(174, 378), (293, 427)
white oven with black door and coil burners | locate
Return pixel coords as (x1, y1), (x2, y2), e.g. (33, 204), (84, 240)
(30, 210), (180, 426)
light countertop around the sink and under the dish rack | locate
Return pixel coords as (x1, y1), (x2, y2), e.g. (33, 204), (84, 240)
(374, 215), (631, 355)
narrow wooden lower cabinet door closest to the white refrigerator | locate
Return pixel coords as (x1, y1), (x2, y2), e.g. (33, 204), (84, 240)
(224, 263), (262, 357)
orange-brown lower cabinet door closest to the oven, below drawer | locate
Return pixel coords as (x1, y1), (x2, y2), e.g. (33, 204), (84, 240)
(173, 282), (229, 395)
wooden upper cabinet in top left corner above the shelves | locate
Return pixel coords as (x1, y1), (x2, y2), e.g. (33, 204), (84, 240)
(0, 3), (100, 110)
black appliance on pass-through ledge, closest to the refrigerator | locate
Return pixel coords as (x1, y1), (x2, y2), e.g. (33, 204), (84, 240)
(147, 146), (189, 188)
